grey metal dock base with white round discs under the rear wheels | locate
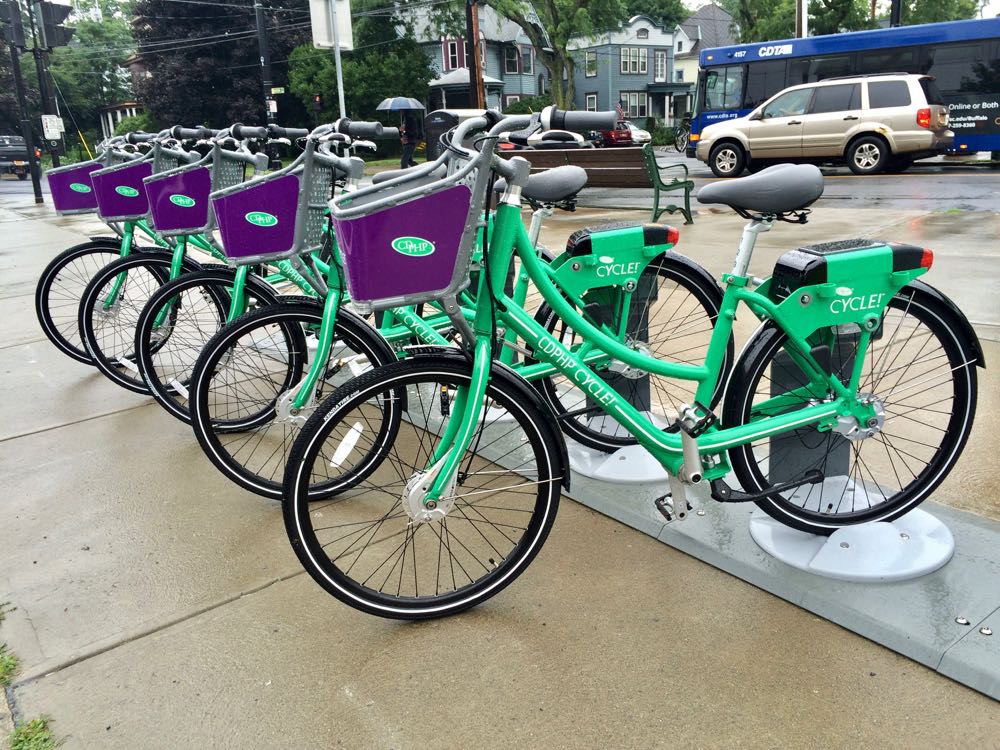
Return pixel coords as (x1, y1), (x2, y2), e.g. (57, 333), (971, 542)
(567, 312), (1000, 700)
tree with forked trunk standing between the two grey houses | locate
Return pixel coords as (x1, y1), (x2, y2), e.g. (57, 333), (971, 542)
(486, 0), (625, 109)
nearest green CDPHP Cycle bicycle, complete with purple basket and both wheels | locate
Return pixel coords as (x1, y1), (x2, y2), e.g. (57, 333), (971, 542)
(284, 108), (983, 619)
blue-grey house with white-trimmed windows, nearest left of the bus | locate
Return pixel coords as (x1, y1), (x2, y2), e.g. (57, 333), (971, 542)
(569, 16), (687, 126)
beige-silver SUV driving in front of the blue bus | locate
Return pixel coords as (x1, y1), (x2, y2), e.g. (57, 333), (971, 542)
(697, 73), (955, 177)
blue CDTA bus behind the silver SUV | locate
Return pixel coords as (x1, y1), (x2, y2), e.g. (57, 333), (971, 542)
(687, 18), (1000, 158)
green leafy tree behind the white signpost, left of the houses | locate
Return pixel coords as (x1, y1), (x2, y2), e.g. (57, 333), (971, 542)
(288, 0), (434, 120)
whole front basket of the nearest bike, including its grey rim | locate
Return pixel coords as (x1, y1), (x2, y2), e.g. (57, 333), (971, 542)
(332, 178), (479, 310)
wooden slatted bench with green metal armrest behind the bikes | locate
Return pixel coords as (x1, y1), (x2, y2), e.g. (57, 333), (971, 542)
(505, 145), (694, 224)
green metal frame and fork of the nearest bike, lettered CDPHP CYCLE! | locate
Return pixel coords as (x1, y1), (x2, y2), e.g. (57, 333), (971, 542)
(414, 199), (927, 504)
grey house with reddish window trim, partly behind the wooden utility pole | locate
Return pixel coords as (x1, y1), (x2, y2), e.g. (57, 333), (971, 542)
(408, 5), (549, 111)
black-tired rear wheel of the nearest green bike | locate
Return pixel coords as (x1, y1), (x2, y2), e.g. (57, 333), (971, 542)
(723, 288), (977, 534)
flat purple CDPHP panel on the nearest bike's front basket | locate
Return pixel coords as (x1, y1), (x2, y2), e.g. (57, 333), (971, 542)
(333, 185), (472, 308)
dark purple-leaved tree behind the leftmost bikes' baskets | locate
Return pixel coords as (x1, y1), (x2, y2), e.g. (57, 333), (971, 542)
(134, 0), (309, 127)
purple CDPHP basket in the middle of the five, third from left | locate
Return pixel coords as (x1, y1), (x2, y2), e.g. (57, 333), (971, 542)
(145, 167), (212, 235)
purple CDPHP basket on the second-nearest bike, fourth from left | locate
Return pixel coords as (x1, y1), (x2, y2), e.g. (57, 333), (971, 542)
(212, 174), (299, 262)
